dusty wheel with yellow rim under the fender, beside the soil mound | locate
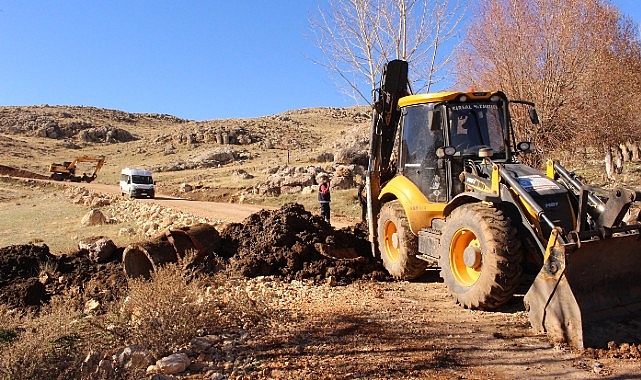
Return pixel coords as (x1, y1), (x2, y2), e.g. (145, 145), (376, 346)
(377, 201), (428, 280)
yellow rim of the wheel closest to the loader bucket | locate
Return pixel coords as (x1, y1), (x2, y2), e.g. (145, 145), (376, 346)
(450, 228), (482, 286)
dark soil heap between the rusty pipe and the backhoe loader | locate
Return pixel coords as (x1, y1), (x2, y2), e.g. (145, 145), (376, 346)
(220, 203), (387, 284)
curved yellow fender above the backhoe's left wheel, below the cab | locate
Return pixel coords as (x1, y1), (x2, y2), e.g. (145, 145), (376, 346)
(378, 175), (447, 234)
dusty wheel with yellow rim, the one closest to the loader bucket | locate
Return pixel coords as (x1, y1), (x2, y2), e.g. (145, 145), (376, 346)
(439, 203), (523, 310)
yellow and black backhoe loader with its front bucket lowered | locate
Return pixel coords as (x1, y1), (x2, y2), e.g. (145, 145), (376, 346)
(366, 60), (641, 348)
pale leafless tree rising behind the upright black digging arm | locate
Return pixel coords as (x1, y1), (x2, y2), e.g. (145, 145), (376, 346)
(310, 0), (464, 104)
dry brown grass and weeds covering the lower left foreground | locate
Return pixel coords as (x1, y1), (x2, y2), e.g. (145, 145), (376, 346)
(0, 258), (276, 379)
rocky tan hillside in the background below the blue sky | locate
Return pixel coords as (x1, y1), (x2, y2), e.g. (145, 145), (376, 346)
(0, 105), (370, 198)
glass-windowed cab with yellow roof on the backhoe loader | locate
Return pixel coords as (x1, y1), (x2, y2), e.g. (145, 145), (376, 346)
(399, 92), (511, 203)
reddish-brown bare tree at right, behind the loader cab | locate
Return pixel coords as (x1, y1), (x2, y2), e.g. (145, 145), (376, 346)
(457, 0), (641, 162)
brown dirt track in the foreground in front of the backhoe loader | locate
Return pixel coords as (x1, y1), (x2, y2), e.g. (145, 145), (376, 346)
(250, 273), (641, 380)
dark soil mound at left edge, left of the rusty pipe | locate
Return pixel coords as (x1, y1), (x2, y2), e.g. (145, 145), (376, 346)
(0, 244), (127, 310)
